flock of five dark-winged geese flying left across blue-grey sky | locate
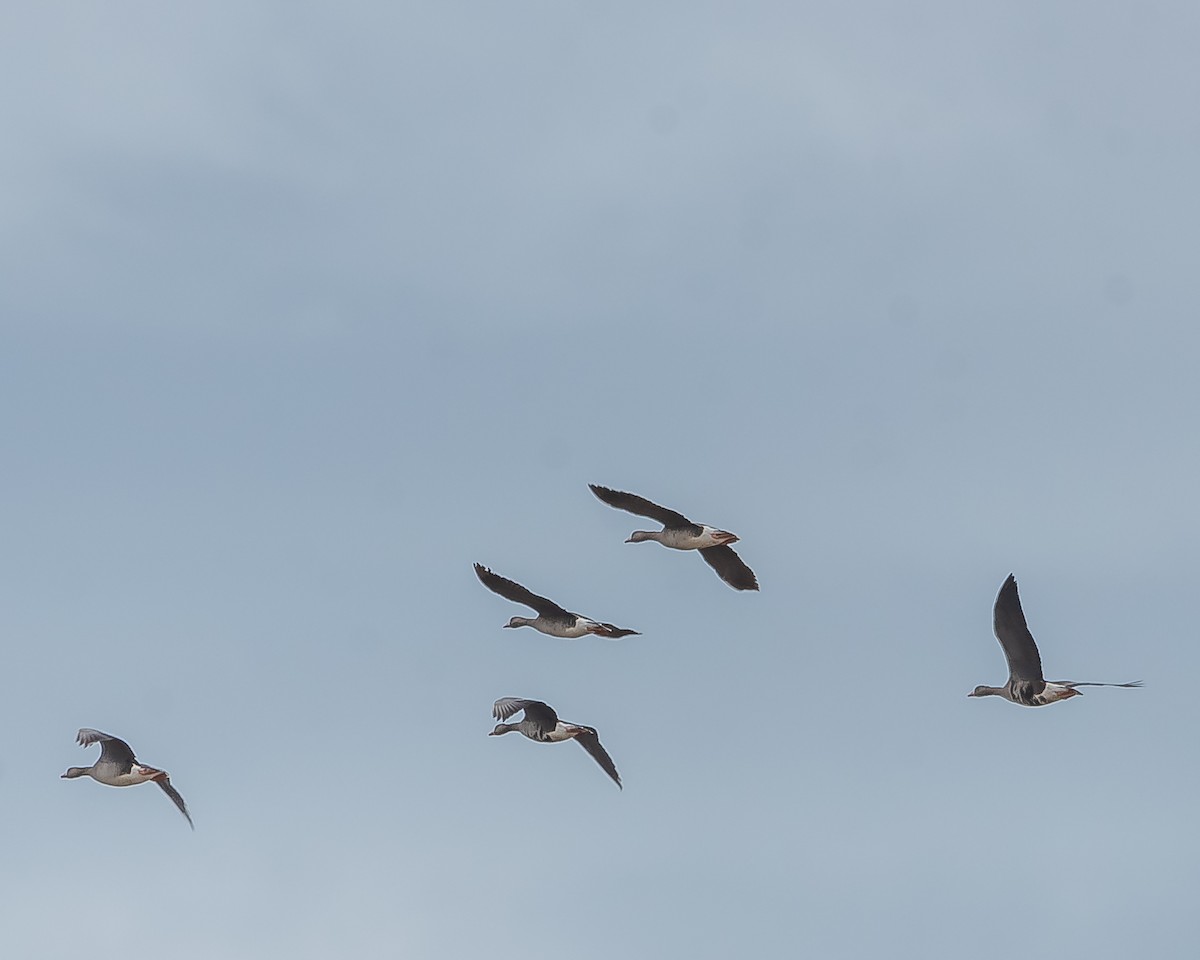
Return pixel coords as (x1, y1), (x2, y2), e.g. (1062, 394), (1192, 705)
(62, 484), (1141, 816)
